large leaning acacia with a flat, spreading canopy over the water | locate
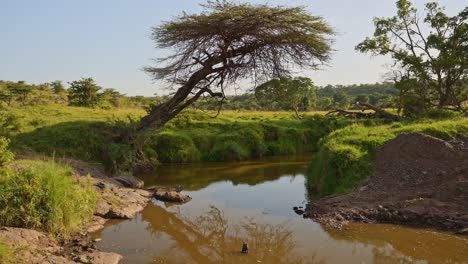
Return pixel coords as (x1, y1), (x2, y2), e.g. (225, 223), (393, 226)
(138, 1), (334, 131)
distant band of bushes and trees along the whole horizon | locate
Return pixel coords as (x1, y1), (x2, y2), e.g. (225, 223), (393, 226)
(0, 77), (398, 116)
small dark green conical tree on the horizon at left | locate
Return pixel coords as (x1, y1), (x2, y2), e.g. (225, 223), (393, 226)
(68, 78), (101, 107)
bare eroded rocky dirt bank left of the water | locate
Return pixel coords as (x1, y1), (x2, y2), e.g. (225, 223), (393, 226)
(0, 160), (152, 264)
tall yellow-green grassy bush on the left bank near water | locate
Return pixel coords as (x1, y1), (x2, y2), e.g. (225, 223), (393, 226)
(0, 161), (98, 236)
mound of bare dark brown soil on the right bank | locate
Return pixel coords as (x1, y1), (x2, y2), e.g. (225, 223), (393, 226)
(306, 133), (468, 233)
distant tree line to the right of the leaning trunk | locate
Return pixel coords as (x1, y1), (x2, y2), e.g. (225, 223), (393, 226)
(195, 81), (398, 112)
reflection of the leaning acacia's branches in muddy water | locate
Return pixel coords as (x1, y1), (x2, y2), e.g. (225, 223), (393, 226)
(142, 204), (326, 264)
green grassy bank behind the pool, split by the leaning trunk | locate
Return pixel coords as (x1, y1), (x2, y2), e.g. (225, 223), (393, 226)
(0, 105), (349, 173)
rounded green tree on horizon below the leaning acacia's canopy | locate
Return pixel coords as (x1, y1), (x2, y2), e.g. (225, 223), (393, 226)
(255, 77), (316, 118)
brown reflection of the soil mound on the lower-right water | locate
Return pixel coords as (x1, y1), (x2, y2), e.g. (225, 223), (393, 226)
(328, 224), (468, 263)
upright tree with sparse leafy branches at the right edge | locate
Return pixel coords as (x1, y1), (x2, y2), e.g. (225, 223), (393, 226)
(356, 0), (468, 112)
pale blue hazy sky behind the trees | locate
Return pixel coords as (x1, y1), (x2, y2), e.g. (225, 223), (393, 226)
(0, 0), (468, 96)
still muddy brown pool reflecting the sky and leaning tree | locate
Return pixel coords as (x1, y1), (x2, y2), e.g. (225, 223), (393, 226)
(94, 156), (468, 264)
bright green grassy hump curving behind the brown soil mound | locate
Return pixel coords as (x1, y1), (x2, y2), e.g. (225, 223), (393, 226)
(307, 119), (468, 195)
